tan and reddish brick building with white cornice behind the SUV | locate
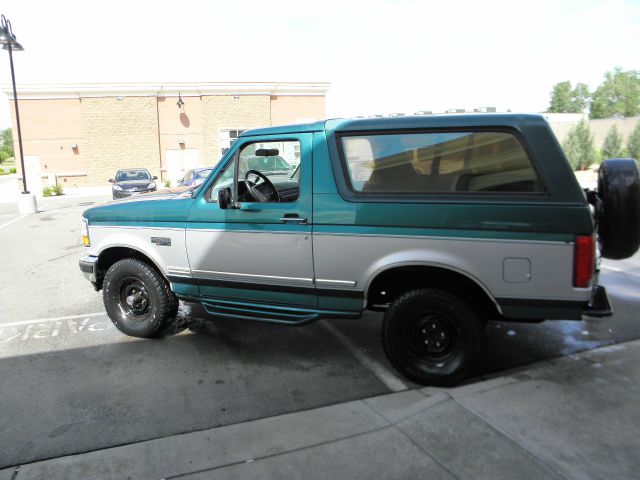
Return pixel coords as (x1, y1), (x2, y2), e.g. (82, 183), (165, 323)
(5, 83), (329, 192)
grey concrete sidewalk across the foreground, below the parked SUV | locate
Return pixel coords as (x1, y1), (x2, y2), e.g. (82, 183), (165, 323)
(0, 340), (640, 480)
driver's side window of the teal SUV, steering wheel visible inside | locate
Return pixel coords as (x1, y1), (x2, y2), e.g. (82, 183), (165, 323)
(209, 140), (300, 203)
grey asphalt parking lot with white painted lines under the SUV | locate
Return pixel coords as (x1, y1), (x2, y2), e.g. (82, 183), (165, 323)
(0, 192), (640, 468)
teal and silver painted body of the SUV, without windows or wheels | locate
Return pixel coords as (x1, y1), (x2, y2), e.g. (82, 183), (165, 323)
(81, 115), (594, 323)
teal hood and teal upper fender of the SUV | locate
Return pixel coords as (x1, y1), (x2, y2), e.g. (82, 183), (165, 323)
(82, 187), (193, 227)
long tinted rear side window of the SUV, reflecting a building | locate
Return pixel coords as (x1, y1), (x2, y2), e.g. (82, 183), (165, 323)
(342, 131), (544, 194)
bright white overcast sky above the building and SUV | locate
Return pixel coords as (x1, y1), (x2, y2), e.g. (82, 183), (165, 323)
(0, 0), (640, 128)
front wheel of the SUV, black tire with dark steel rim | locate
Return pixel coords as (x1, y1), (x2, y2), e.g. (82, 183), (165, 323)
(102, 258), (178, 338)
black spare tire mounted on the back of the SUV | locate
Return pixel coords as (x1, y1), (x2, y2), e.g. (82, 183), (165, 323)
(596, 158), (640, 260)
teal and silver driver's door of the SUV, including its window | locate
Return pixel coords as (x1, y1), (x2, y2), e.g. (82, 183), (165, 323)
(186, 134), (317, 306)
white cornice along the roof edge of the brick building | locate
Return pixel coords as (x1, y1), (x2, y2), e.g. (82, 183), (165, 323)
(0, 82), (331, 99)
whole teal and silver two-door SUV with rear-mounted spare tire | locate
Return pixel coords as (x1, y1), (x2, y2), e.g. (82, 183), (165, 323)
(80, 114), (640, 385)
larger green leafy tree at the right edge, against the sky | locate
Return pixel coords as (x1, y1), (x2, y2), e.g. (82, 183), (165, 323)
(590, 67), (640, 118)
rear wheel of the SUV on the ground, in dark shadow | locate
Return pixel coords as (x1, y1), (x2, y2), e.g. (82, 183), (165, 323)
(382, 289), (484, 386)
